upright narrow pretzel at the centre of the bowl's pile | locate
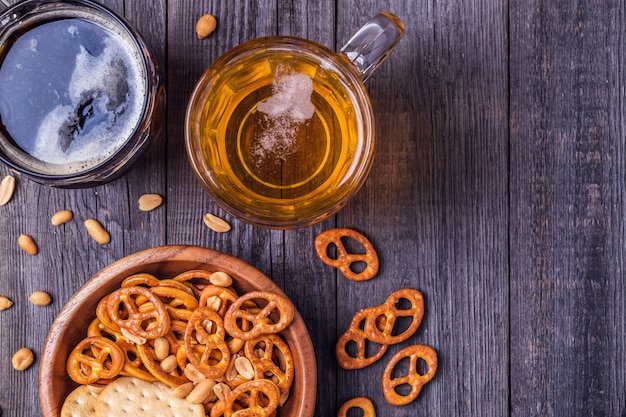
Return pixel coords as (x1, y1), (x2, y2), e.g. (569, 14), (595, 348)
(185, 307), (230, 379)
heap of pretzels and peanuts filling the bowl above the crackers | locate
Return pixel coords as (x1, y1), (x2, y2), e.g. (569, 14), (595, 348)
(66, 270), (294, 417)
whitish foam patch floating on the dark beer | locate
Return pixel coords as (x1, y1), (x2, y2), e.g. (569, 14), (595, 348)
(32, 27), (145, 172)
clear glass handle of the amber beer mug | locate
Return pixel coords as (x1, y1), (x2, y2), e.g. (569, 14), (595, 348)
(339, 12), (404, 81)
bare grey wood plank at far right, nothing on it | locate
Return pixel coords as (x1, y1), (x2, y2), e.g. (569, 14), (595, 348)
(510, 1), (626, 416)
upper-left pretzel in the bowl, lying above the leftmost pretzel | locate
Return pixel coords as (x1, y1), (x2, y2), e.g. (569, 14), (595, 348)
(107, 286), (170, 339)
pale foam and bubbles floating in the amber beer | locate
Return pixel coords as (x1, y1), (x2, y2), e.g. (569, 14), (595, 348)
(253, 67), (315, 163)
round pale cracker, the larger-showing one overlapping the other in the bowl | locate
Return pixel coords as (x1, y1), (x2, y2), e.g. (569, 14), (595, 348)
(96, 377), (205, 417)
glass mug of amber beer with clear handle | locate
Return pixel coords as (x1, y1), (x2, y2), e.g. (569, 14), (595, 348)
(185, 12), (404, 229)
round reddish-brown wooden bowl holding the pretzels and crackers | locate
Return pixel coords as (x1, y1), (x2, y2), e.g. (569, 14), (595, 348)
(39, 246), (317, 417)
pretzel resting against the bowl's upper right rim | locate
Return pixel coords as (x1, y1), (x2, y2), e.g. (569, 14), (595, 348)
(224, 291), (294, 340)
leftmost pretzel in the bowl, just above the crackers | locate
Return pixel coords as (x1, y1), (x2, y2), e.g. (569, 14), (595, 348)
(66, 336), (124, 384)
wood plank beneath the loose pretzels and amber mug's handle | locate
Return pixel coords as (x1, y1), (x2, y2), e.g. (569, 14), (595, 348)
(337, 1), (508, 416)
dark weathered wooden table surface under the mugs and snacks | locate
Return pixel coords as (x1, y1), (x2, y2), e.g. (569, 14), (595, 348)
(0, 0), (626, 417)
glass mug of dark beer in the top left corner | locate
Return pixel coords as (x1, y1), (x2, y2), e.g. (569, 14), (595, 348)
(0, 0), (165, 188)
